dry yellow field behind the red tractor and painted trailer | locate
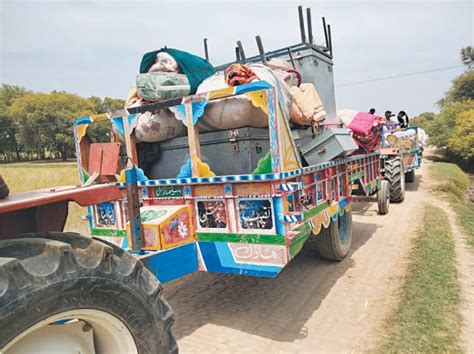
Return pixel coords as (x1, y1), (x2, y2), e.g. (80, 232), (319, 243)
(0, 162), (88, 235)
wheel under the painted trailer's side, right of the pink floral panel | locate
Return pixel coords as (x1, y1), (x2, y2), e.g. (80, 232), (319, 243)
(316, 211), (352, 261)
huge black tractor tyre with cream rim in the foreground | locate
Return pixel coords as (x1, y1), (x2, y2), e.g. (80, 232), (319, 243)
(0, 232), (178, 354)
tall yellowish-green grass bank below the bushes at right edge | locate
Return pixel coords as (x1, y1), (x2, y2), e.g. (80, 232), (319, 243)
(431, 162), (474, 250)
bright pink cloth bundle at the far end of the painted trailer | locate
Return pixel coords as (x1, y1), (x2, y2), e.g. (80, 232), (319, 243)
(347, 112), (382, 153)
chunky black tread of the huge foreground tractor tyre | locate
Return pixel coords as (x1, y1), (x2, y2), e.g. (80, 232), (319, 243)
(0, 232), (177, 353)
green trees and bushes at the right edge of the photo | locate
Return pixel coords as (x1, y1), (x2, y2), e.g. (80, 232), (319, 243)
(411, 46), (474, 171)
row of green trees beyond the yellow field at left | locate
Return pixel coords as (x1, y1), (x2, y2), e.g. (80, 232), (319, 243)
(0, 84), (125, 162)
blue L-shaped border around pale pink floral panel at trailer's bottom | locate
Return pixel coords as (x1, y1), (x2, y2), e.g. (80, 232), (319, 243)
(199, 242), (283, 277)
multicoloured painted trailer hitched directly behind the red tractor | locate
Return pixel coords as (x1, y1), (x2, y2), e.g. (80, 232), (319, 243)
(75, 81), (388, 282)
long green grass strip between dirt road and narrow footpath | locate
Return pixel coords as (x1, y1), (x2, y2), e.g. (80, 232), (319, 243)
(380, 205), (462, 352)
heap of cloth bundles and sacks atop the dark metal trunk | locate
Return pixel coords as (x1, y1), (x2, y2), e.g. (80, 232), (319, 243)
(125, 48), (326, 142)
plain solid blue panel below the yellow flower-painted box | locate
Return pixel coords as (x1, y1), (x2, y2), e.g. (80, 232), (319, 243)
(140, 242), (198, 283)
